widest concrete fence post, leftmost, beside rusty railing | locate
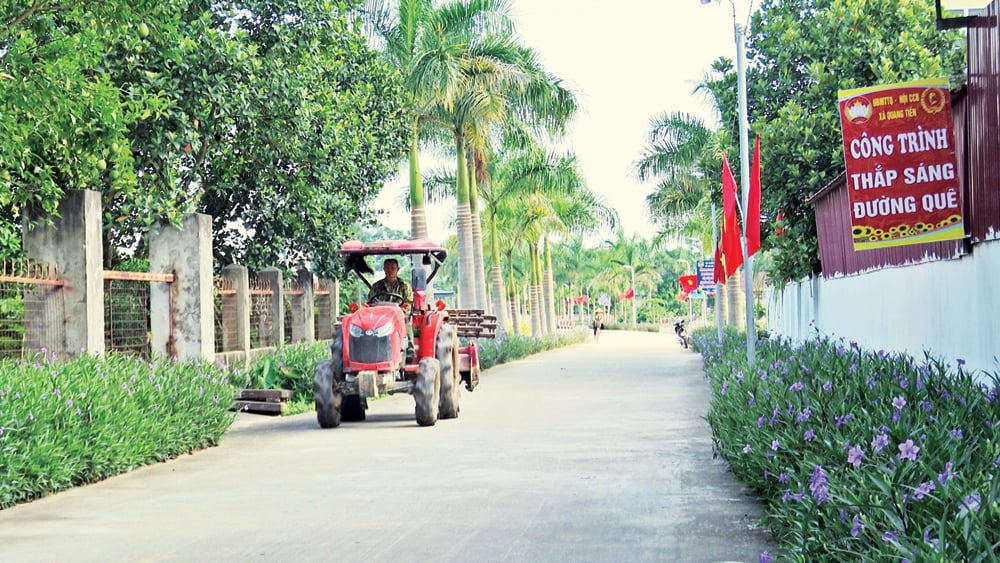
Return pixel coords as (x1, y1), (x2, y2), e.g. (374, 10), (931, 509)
(22, 190), (104, 355)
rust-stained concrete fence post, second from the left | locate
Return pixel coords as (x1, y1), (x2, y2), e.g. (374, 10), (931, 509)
(149, 213), (215, 360)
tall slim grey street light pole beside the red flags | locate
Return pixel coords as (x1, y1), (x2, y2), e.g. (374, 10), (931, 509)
(701, 0), (757, 365)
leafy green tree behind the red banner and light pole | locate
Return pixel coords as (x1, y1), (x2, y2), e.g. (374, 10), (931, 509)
(752, 0), (965, 284)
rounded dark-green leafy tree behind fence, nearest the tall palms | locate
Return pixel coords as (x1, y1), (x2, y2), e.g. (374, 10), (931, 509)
(197, 0), (409, 272)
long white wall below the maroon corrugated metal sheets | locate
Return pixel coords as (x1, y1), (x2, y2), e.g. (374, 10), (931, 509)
(767, 241), (1000, 373)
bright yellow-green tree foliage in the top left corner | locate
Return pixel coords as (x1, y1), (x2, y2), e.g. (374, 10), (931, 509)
(0, 0), (147, 252)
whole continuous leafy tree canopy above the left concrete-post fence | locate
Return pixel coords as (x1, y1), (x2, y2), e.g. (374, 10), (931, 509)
(0, 0), (410, 275)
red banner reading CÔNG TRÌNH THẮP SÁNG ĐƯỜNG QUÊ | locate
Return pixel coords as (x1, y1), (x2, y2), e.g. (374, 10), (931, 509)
(839, 78), (965, 250)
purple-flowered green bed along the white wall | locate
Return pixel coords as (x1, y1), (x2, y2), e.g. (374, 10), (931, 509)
(693, 330), (1000, 561)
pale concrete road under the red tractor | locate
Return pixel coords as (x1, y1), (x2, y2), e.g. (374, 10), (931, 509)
(0, 331), (775, 563)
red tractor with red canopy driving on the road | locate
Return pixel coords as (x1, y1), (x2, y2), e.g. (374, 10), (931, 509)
(313, 240), (486, 428)
